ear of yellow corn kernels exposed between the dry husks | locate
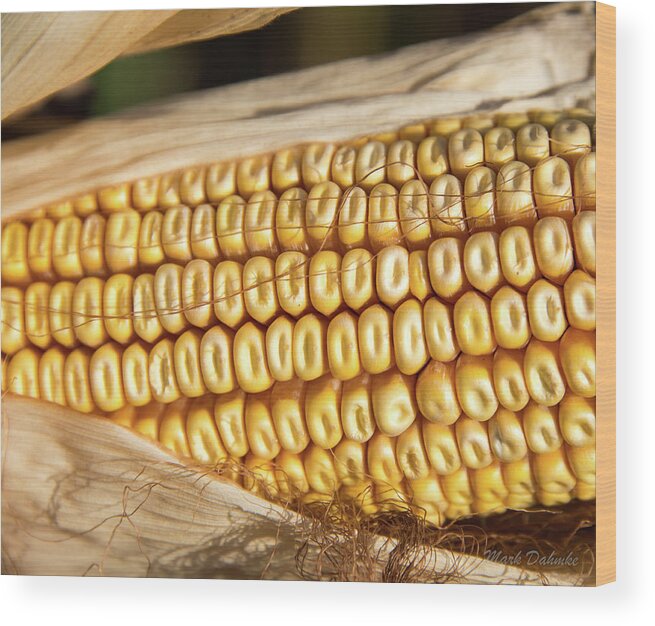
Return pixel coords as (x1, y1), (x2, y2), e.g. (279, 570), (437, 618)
(2, 111), (595, 524)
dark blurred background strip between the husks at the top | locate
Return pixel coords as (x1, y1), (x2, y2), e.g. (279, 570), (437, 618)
(2, 3), (547, 141)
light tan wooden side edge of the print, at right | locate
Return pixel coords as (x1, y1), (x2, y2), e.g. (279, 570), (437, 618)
(596, 3), (616, 585)
